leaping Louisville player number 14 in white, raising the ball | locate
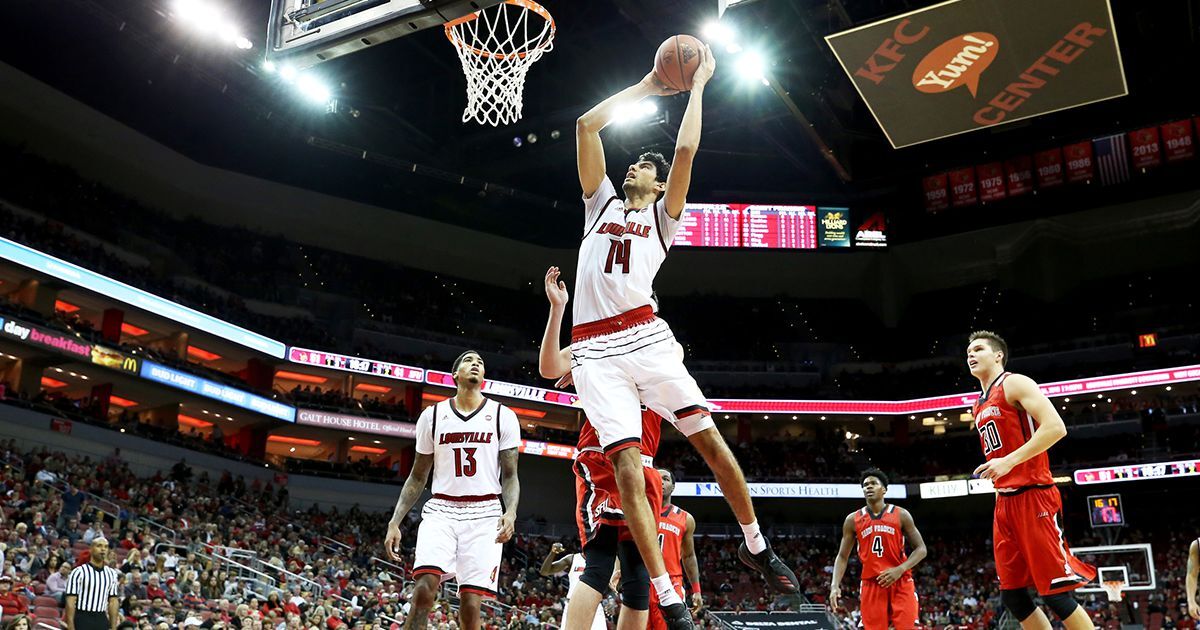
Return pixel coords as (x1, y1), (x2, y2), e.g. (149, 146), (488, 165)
(571, 42), (799, 628)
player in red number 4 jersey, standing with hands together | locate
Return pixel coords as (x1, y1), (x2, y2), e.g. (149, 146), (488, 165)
(829, 468), (928, 630)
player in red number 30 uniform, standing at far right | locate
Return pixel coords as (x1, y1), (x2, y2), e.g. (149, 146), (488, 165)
(967, 330), (1096, 630)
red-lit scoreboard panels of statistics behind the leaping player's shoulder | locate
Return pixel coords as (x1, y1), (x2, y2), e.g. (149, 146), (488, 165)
(673, 204), (817, 250)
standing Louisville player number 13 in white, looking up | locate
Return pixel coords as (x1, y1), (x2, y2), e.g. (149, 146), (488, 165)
(384, 350), (521, 630)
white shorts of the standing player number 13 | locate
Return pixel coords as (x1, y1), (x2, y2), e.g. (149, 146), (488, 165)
(413, 498), (504, 598)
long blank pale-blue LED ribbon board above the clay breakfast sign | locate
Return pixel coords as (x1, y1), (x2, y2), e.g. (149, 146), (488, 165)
(0, 236), (287, 359)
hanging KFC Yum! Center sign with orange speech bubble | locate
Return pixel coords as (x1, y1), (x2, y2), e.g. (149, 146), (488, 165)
(826, 0), (1128, 149)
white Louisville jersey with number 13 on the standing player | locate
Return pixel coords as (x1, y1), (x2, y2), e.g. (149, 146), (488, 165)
(416, 398), (521, 497)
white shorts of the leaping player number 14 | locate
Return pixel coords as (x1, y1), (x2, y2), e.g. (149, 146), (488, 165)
(571, 318), (714, 452)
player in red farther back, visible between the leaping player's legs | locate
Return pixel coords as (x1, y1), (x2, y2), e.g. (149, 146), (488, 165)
(649, 468), (704, 630)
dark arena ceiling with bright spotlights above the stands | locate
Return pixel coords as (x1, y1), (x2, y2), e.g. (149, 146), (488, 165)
(0, 0), (1200, 244)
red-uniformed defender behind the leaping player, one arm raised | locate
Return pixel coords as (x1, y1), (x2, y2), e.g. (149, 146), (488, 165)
(538, 268), (662, 630)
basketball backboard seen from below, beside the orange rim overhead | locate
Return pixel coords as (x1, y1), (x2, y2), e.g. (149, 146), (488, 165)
(266, 0), (502, 70)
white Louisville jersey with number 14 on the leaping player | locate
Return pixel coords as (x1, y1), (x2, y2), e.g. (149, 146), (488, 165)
(572, 178), (679, 325)
